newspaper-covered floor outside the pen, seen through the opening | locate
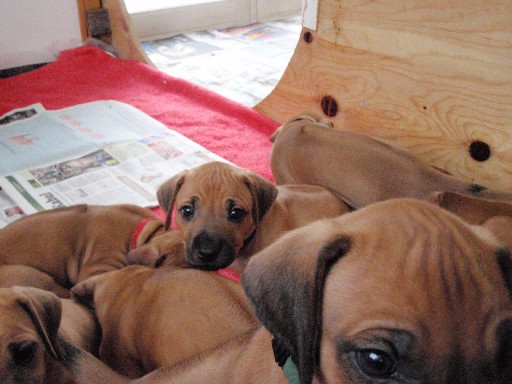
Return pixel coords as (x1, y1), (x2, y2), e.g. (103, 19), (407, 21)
(143, 15), (301, 107)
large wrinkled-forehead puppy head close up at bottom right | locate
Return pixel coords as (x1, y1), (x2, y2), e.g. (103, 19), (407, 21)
(242, 199), (512, 384)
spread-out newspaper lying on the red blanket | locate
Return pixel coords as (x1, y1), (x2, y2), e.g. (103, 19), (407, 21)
(0, 101), (226, 218)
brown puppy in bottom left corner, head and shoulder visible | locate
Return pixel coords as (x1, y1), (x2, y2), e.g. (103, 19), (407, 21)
(0, 287), (100, 384)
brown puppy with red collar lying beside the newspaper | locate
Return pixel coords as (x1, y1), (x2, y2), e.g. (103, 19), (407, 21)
(0, 205), (185, 288)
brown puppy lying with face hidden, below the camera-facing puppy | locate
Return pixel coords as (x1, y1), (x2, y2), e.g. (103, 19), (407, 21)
(72, 266), (257, 377)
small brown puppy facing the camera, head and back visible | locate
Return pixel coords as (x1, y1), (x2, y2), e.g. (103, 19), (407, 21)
(157, 162), (349, 272)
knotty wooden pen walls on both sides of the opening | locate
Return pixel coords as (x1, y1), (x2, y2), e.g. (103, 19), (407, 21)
(85, 0), (512, 190)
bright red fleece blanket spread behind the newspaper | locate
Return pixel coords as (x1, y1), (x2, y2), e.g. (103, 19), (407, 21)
(0, 47), (278, 180)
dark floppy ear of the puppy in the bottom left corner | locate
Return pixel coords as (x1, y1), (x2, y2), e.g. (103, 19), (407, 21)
(12, 287), (62, 359)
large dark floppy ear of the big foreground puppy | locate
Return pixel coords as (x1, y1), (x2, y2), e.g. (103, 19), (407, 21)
(242, 228), (351, 384)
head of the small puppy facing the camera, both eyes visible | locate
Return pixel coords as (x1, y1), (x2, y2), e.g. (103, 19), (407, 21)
(157, 162), (277, 270)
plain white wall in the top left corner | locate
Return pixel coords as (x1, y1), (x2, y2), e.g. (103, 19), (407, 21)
(0, 0), (81, 69)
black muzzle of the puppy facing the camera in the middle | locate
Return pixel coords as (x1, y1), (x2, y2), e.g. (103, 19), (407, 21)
(187, 232), (236, 271)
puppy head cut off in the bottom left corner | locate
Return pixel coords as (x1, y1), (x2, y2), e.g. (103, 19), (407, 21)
(0, 287), (62, 384)
